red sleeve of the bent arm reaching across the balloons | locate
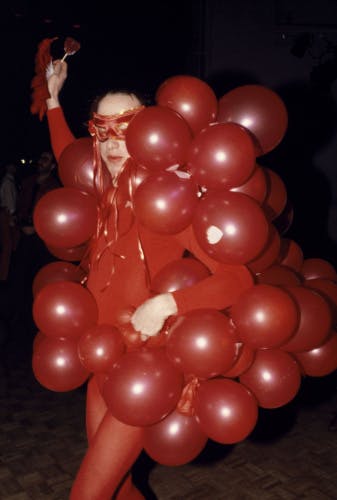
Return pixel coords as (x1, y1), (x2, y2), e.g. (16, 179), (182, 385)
(173, 226), (254, 314)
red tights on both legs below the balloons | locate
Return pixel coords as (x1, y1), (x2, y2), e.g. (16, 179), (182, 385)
(70, 378), (144, 500)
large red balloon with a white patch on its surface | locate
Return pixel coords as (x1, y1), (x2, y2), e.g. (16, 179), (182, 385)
(192, 191), (269, 264)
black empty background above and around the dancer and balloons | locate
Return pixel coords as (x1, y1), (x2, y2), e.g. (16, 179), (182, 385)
(0, 0), (337, 264)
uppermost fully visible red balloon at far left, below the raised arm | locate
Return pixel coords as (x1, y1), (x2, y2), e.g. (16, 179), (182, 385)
(33, 188), (97, 248)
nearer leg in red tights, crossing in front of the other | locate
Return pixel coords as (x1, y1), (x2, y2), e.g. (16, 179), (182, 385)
(70, 412), (144, 500)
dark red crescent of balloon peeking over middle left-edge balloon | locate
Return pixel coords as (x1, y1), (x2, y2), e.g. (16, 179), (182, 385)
(32, 261), (84, 297)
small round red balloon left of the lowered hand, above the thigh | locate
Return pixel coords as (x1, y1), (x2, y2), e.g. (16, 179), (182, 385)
(78, 325), (125, 372)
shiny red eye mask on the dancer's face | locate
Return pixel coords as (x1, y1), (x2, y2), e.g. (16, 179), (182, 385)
(89, 106), (144, 142)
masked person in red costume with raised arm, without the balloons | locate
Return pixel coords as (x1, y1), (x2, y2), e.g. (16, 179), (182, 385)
(41, 56), (253, 500)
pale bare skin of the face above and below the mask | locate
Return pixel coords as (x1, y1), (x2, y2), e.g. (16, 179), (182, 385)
(97, 93), (141, 177)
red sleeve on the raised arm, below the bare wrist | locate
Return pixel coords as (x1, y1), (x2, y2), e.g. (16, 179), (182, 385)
(47, 108), (75, 161)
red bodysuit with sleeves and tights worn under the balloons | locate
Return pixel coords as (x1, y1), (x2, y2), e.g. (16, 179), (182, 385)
(47, 108), (253, 500)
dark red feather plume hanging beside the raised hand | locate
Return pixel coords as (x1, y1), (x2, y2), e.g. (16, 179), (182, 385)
(30, 37), (57, 120)
